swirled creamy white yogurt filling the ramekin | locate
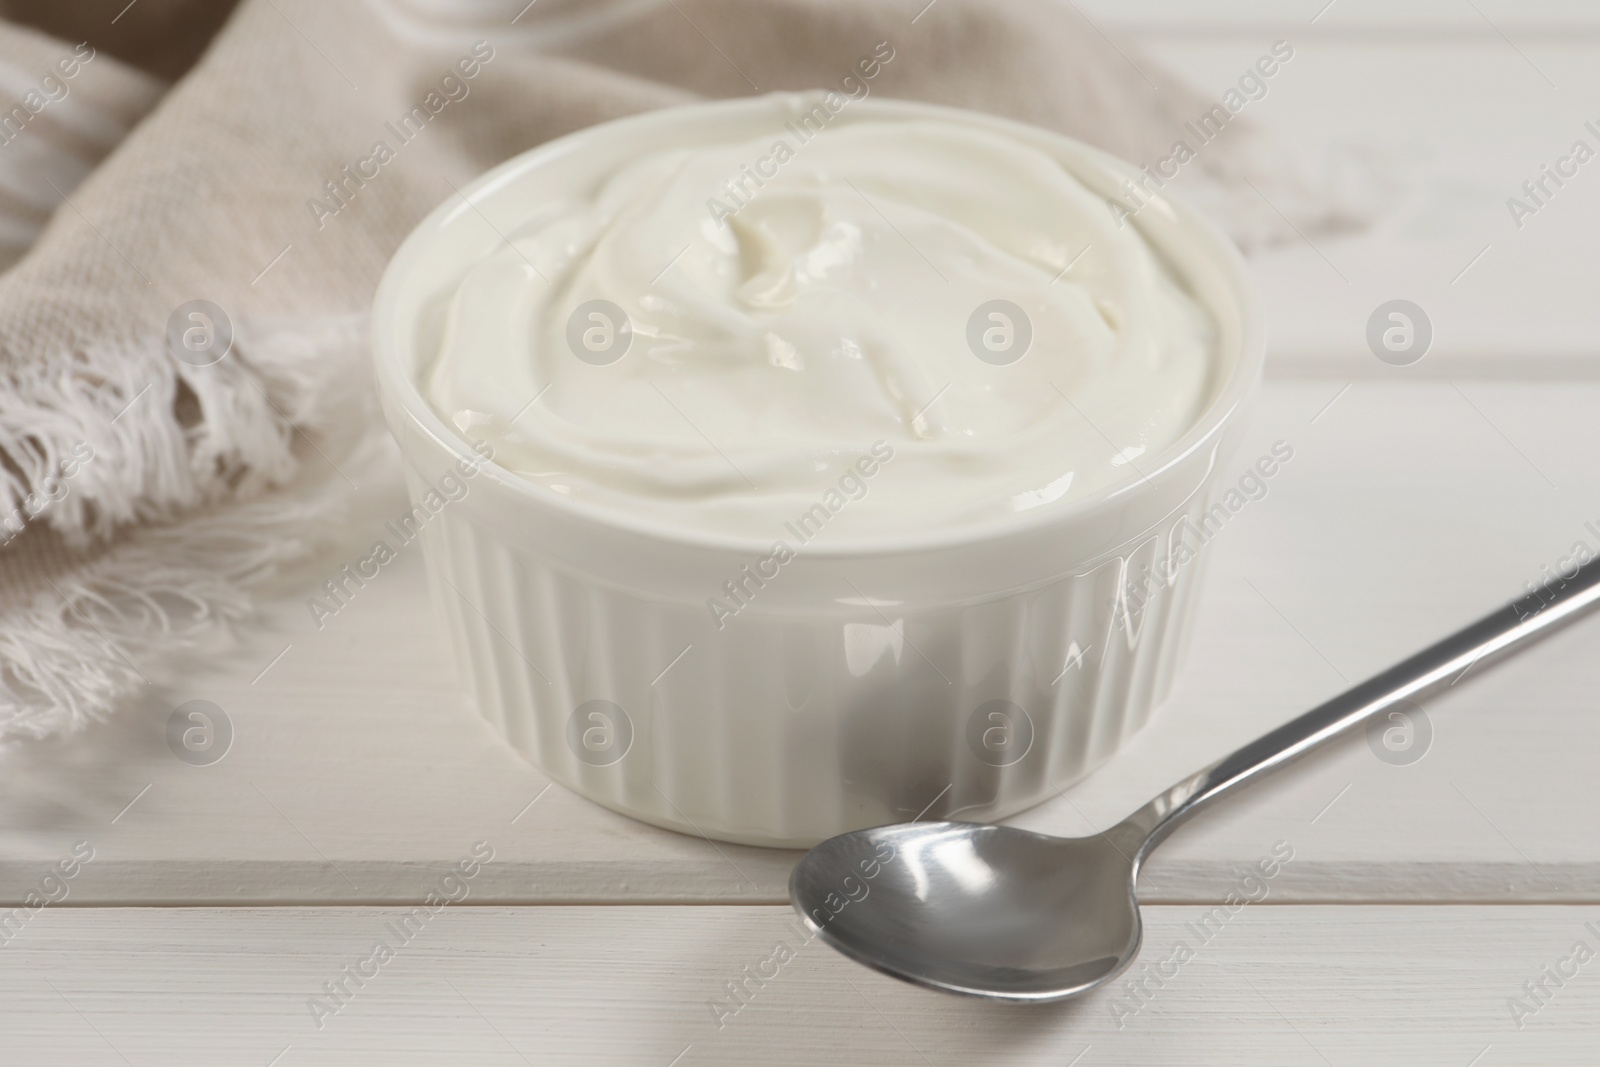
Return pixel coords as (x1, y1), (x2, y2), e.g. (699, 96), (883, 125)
(422, 96), (1214, 539)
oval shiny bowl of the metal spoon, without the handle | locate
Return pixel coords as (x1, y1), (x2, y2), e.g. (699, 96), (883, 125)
(789, 822), (1141, 1001)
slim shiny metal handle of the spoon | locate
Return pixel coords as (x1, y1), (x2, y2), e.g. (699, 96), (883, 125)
(1110, 560), (1600, 861)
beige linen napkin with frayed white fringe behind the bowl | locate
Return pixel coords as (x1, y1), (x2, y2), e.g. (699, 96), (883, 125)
(0, 0), (1354, 739)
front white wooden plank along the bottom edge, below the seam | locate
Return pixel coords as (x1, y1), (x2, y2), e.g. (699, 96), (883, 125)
(0, 897), (1600, 1067)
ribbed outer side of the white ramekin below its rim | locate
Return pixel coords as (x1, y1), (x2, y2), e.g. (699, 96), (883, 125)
(412, 483), (1198, 846)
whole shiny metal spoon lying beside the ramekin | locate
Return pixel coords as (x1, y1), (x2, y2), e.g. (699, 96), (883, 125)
(789, 560), (1600, 1001)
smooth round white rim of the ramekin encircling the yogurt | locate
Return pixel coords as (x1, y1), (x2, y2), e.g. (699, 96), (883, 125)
(370, 90), (1266, 558)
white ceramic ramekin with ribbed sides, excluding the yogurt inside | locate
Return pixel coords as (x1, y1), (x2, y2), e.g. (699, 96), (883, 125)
(373, 96), (1264, 846)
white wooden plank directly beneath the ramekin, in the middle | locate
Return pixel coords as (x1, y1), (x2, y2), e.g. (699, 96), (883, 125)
(0, 382), (1600, 904)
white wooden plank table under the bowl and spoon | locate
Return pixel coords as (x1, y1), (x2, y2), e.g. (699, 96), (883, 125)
(0, 0), (1600, 1067)
